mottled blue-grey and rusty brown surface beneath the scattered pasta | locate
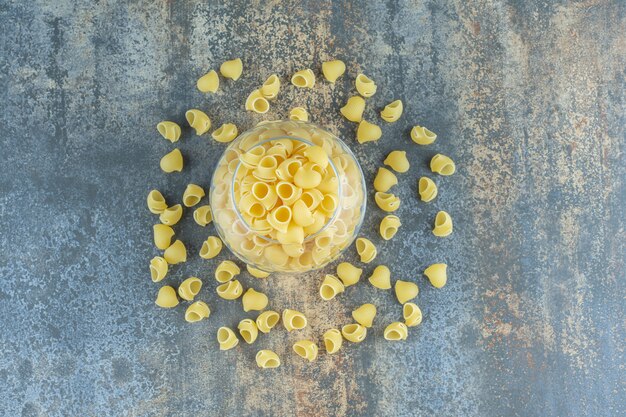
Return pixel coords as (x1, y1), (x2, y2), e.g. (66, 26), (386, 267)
(0, 0), (626, 416)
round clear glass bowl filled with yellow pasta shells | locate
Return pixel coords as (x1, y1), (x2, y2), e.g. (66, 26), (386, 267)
(209, 120), (366, 273)
